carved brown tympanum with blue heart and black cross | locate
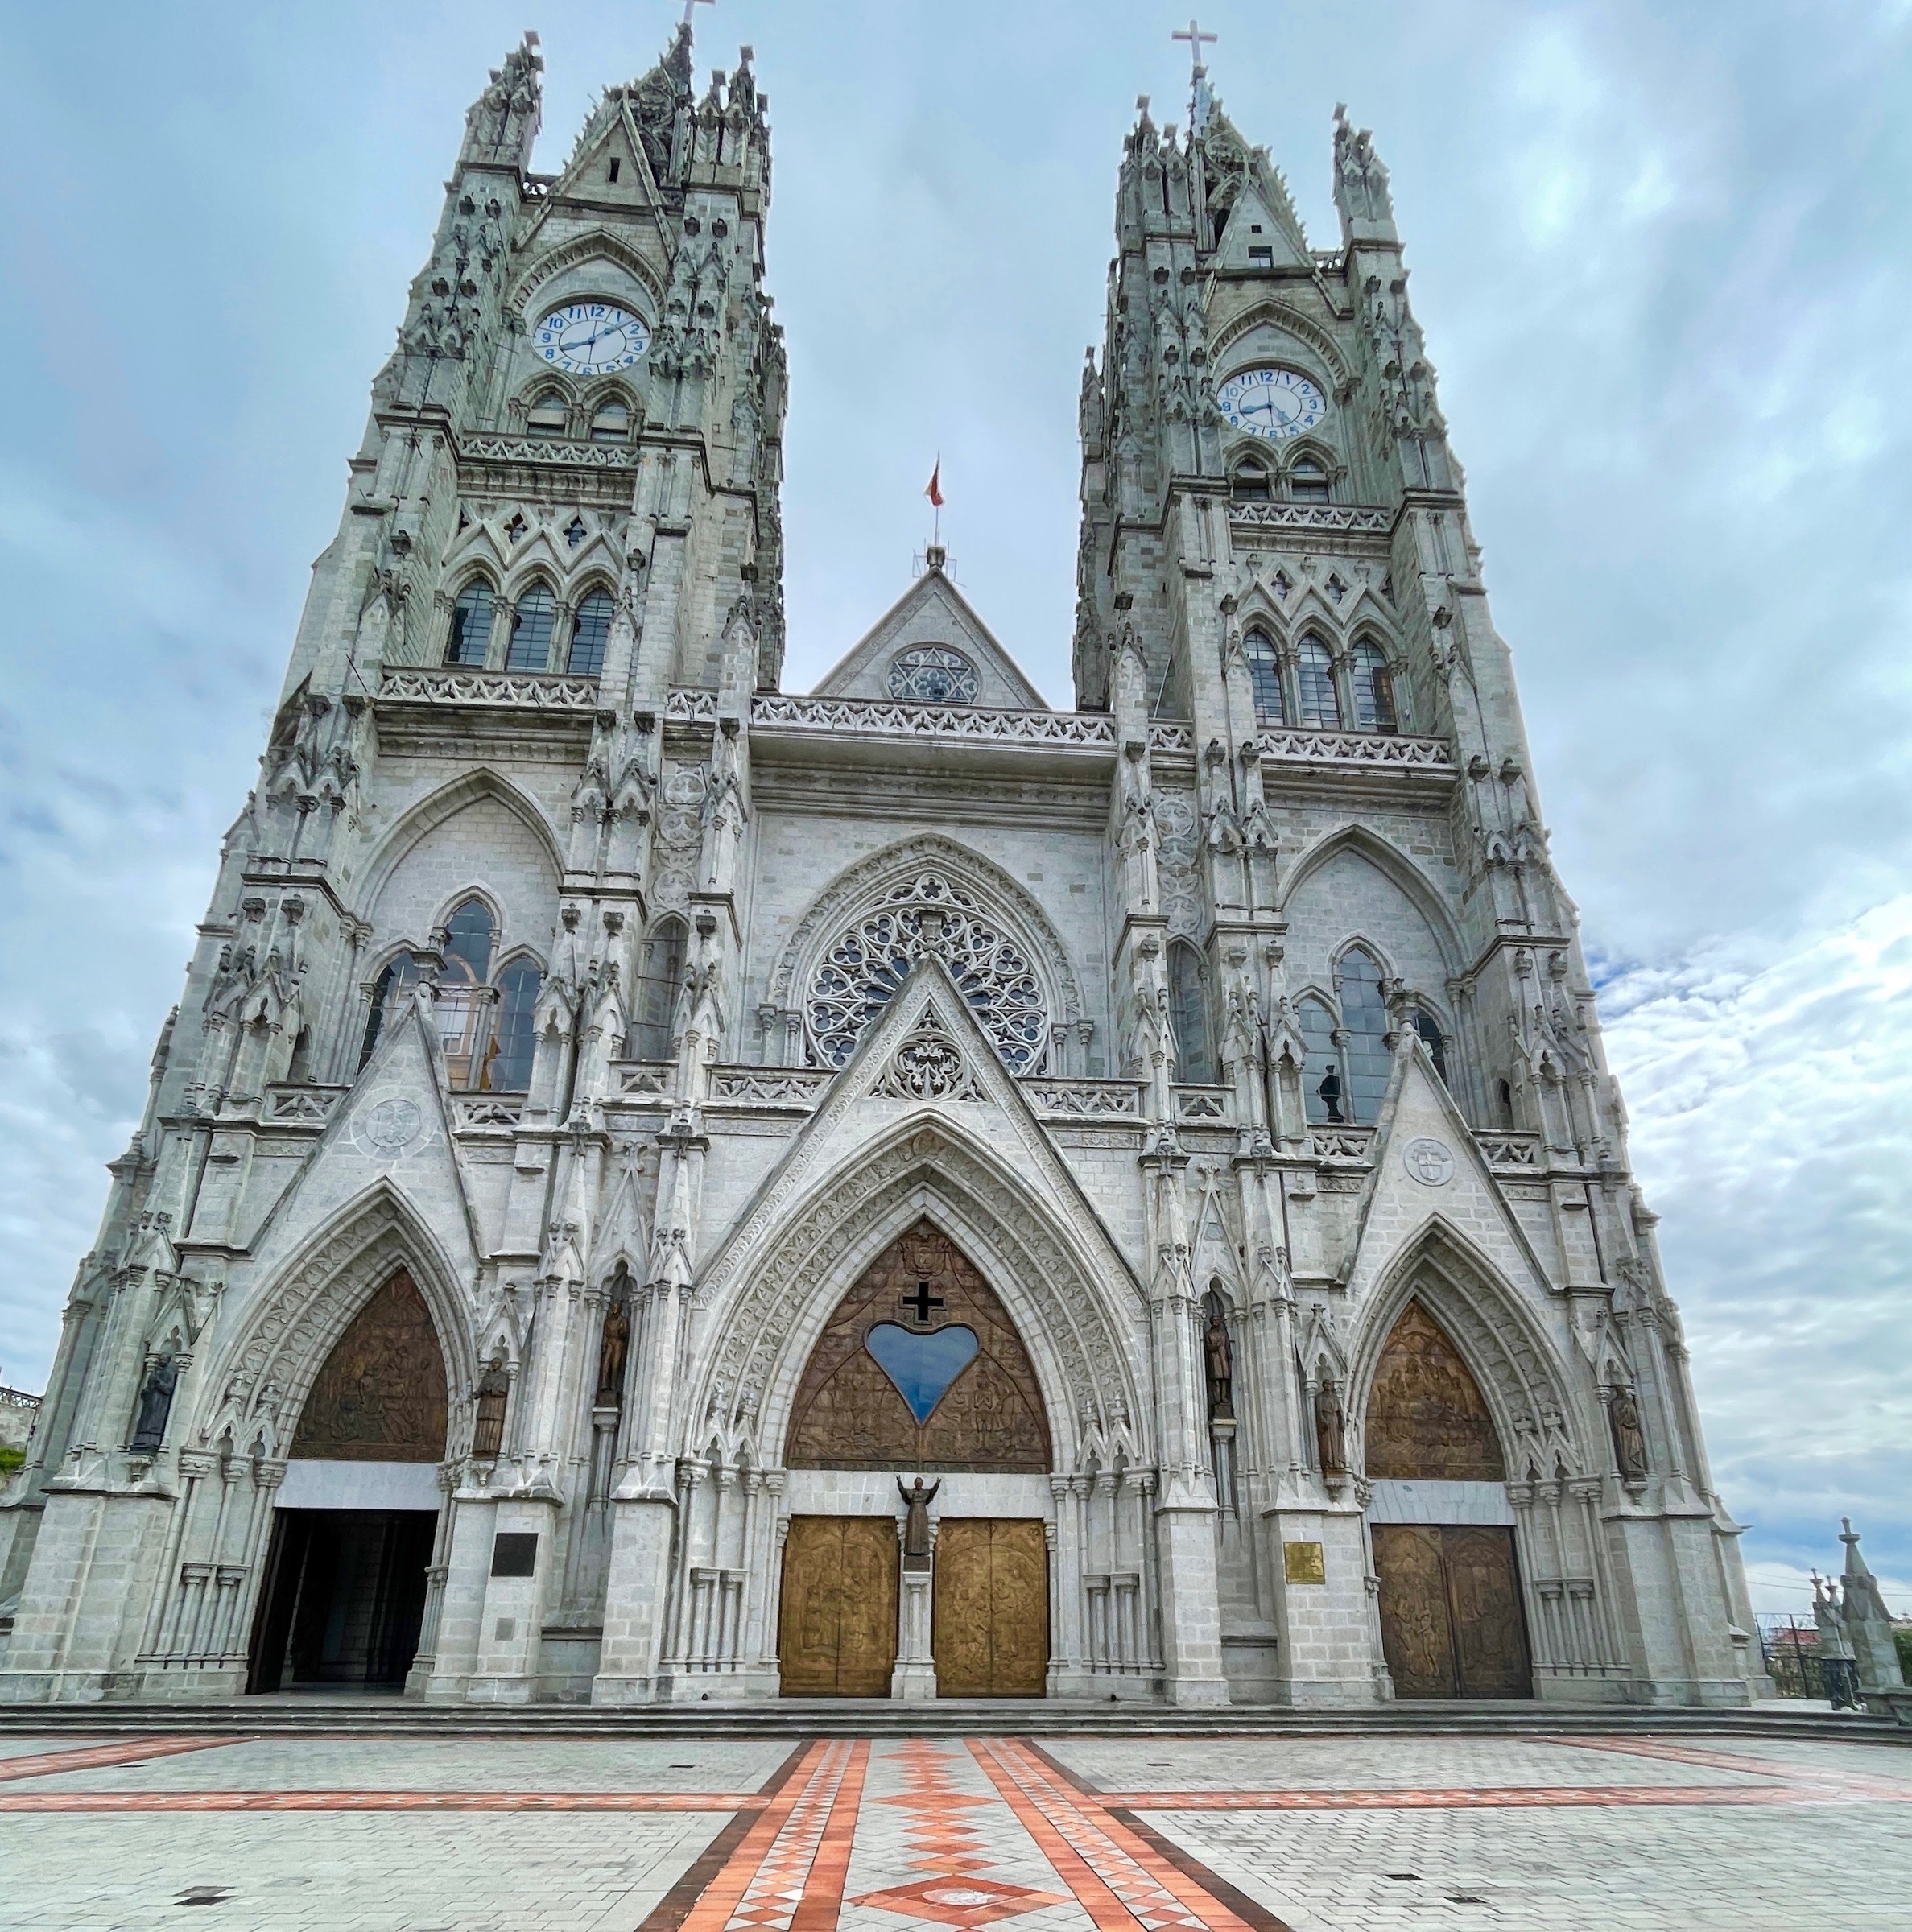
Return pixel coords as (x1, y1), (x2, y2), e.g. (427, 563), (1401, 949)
(784, 1221), (1049, 1472)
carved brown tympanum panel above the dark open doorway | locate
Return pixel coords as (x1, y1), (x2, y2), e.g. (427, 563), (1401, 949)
(291, 1269), (444, 1463)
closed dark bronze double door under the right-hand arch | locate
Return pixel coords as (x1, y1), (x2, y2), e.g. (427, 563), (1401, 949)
(1373, 1522), (1534, 1699)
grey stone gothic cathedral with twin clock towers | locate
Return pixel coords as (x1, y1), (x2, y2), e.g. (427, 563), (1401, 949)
(0, 27), (1757, 1706)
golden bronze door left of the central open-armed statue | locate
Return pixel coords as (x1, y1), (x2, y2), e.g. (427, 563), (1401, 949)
(778, 1517), (896, 1696)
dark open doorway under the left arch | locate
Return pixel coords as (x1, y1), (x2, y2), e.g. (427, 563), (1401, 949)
(247, 1509), (439, 1690)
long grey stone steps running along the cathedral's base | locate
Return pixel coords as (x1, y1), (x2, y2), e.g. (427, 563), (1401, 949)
(0, 1695), (1912, 1744)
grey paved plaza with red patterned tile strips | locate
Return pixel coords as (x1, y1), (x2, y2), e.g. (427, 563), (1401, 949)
(0, 1733), (1912, 1932)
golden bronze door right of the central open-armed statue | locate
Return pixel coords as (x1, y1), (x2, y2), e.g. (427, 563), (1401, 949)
(931, 1517), (1049, 1696)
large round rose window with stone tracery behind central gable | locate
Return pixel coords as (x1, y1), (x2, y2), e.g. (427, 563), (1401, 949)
(805, 871), (1049, 1074)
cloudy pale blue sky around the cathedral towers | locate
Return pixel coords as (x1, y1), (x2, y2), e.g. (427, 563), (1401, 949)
(0, 0), (1912, 1612)
